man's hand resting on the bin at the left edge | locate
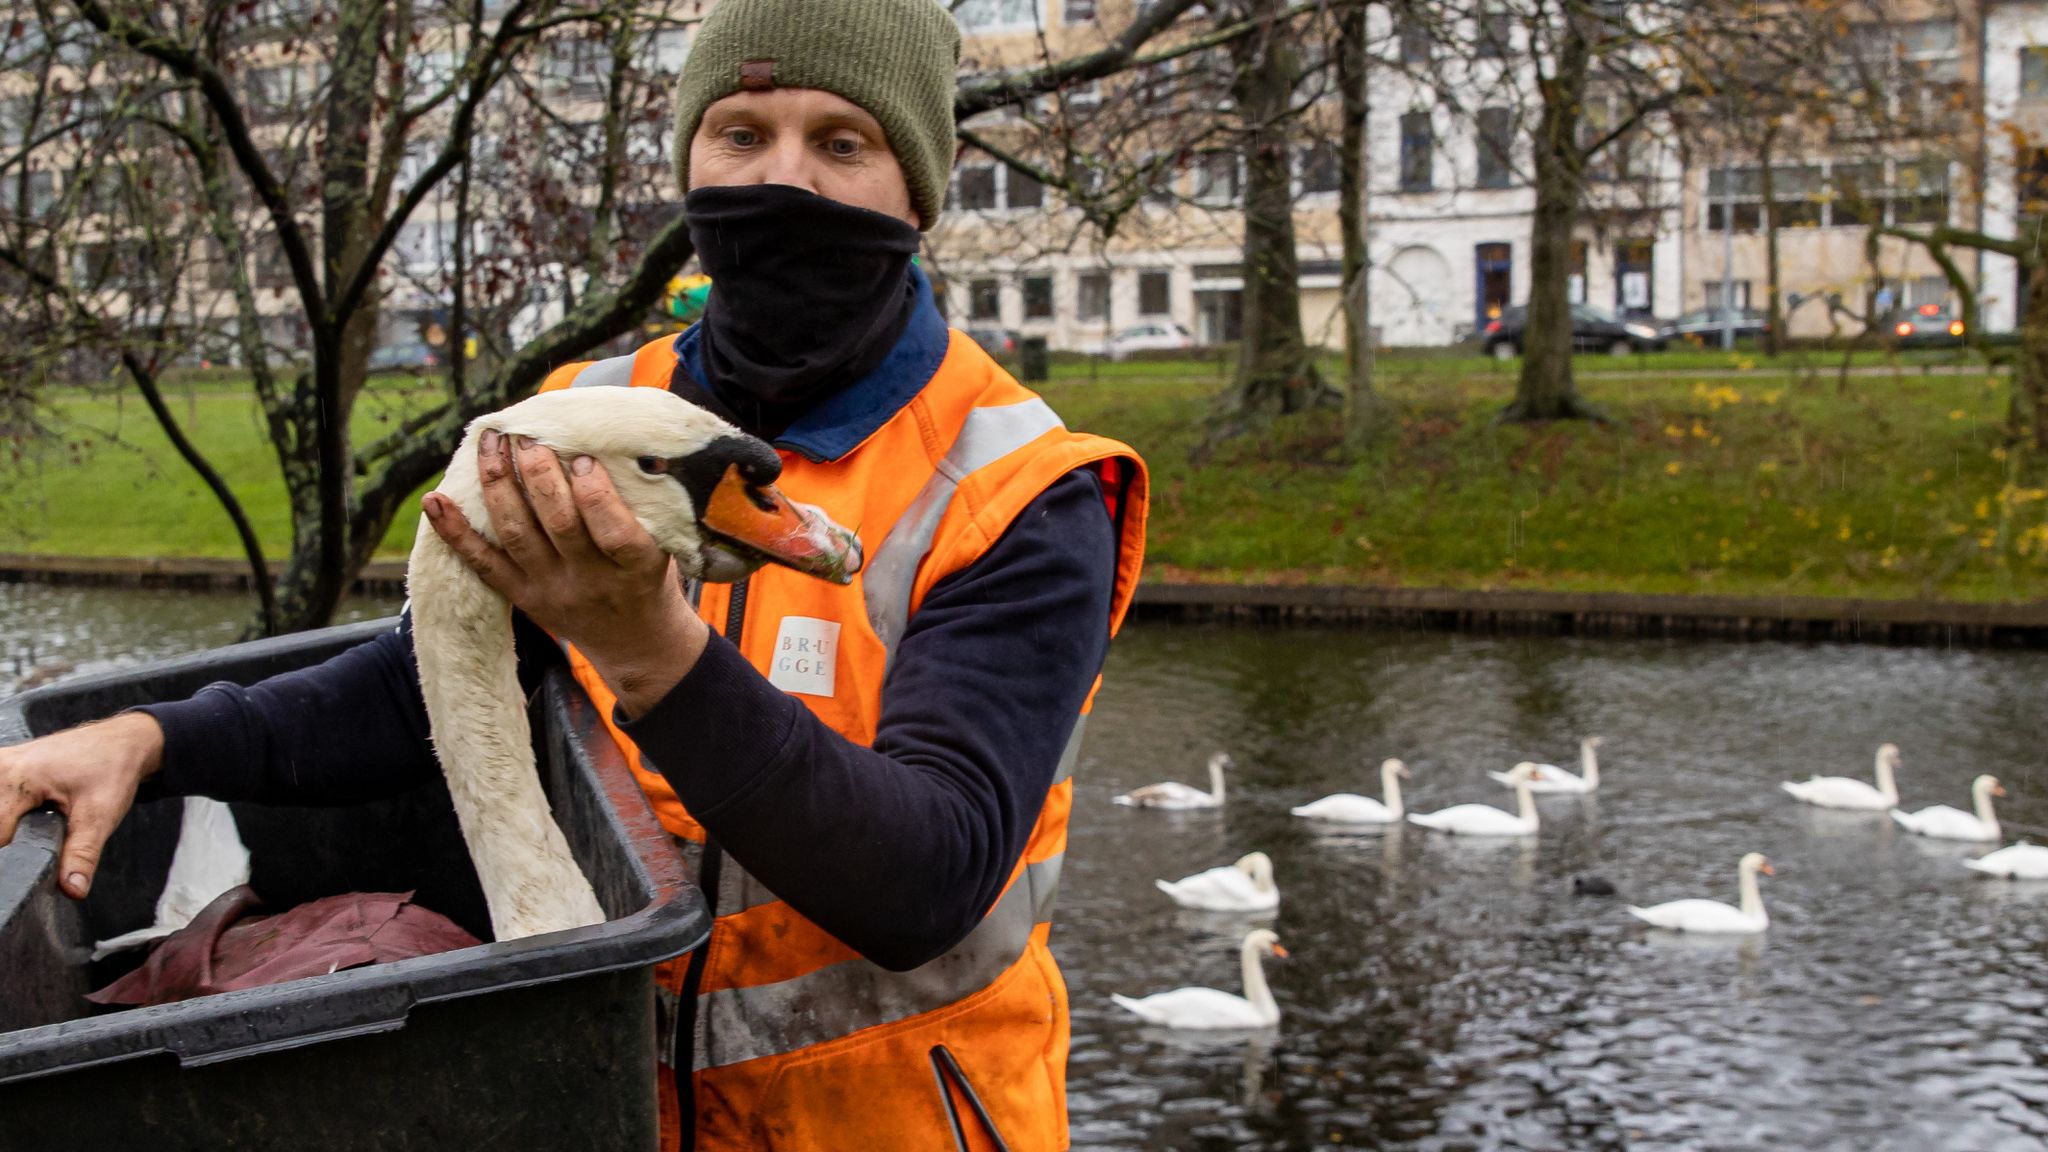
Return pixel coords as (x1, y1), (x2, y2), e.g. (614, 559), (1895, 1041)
(0, 711), (164, 900)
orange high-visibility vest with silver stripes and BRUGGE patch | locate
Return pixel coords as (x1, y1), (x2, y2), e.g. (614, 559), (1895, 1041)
(543, 332), (1147, 1152)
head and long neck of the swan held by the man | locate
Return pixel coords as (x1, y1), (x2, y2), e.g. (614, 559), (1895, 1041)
(406, 387), (860, 941)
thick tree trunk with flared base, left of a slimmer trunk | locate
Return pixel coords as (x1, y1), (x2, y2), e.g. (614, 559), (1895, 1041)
(1219, 0), (1331, 435)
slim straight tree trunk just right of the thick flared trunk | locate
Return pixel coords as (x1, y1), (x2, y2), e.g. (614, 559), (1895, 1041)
(1337, 4), (1380, 449)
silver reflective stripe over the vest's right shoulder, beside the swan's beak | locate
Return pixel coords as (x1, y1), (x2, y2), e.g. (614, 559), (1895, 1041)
(860, 398), (1065, 660)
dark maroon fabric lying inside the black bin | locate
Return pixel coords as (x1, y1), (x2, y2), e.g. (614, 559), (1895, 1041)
(86, 886), (479, 1004)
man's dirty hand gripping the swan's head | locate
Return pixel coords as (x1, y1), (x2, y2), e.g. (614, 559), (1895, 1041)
(420, 433), (711, 715)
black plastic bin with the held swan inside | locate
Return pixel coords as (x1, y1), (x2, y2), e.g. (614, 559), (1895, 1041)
(0, 621), (711, 1152)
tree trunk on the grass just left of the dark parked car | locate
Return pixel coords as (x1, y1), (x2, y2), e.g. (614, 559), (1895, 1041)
(1503, 10), (1593, 420)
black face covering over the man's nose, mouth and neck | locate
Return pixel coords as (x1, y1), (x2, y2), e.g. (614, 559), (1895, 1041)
(682, 184), (920, 437)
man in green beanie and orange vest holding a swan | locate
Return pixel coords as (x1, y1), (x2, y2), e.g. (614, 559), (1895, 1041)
(0, 0), (1145, 1148)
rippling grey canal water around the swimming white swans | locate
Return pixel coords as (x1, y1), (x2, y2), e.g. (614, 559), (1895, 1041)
(0, 586), (2048, 1152)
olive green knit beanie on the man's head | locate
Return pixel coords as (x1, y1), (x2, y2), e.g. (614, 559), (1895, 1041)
(676, 0), (961, 228)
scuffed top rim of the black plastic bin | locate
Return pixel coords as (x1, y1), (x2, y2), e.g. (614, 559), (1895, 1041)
(0, 617), (711, 1084)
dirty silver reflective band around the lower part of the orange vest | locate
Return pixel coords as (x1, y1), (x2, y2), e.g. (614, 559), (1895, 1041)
(694, 857), (1063, 1068)
